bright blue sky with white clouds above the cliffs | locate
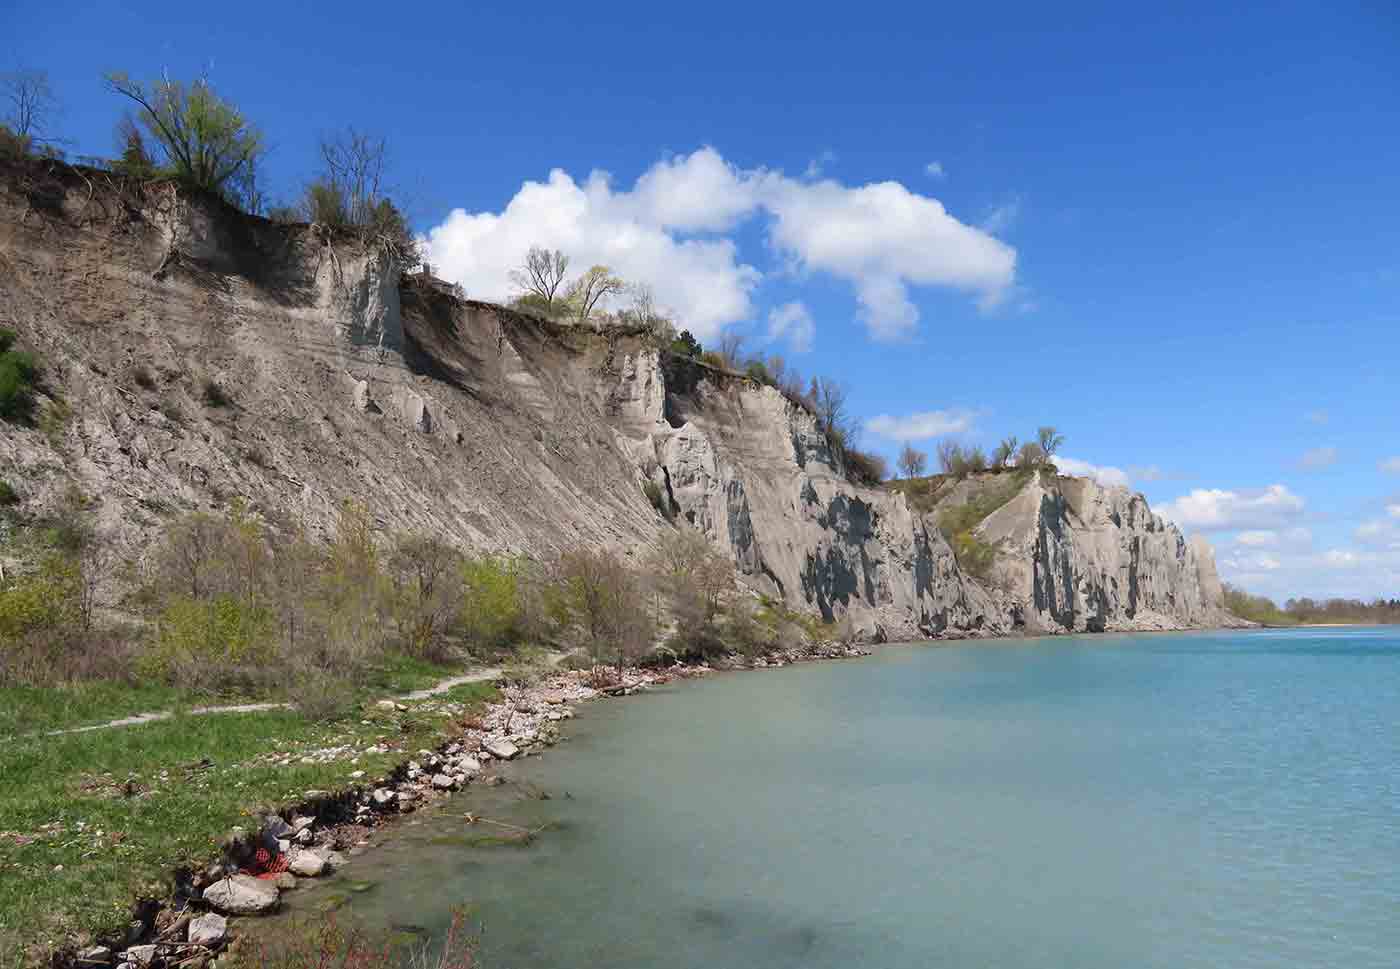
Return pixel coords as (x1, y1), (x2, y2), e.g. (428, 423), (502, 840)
(0, 0), (1400, 597)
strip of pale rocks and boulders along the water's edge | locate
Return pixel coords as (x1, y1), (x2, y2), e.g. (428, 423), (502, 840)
(57, 643), (869, 969)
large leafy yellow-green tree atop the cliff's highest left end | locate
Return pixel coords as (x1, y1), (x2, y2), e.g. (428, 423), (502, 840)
(106, 73), (266, 202)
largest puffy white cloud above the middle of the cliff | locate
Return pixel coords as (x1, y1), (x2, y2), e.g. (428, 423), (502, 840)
(424, 147), (1016, 339)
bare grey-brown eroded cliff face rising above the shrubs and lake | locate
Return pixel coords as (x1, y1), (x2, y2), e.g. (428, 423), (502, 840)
(0, 167), (1224, 639)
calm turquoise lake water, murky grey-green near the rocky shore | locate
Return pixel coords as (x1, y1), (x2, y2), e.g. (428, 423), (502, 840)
(322, 627), (1400, 969)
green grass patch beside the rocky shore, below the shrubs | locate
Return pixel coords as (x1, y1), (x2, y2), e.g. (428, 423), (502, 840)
(0, 677), (494, 966)
